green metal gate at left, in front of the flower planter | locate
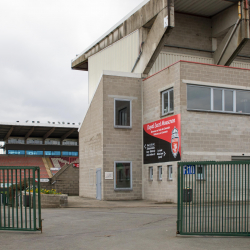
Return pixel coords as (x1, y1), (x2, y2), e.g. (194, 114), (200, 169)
(0, 167), (42, 231)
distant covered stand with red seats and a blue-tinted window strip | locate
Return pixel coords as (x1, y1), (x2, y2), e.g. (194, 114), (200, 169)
(0, 121), (79, 186)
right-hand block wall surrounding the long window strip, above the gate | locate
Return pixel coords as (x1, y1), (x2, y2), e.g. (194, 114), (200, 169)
(180, 62), (250, 161)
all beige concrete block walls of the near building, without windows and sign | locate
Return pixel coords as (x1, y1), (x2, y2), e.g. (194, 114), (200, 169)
(76, 62), (250, 202)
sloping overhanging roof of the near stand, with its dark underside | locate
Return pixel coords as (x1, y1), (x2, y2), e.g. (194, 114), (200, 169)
(71, 0), (238, 71)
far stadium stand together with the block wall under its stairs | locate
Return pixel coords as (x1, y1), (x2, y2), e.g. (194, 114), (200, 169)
(0, 121), (79, 194)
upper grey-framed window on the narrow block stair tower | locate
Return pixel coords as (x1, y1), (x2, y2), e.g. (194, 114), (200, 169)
(114, 99), (132, 128)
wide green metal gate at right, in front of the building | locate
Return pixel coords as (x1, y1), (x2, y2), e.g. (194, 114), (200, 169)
(177, 161), (250, 236)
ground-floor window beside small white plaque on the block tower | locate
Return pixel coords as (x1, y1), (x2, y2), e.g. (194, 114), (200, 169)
(114, 161), (132, 190)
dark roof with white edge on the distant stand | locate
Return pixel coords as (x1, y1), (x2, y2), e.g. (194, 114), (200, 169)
(0, 122), (79, 141)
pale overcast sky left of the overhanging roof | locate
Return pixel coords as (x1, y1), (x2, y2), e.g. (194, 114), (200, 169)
(0, 0), (143, 123)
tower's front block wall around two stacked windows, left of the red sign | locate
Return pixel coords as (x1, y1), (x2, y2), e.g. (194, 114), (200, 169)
(103, 75), (142, 200)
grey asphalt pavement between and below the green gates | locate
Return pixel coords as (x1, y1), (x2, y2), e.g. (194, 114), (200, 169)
(0, 200), (250, 250)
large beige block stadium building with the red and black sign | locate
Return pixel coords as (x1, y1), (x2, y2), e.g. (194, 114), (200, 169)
(71, 0), (250, 202)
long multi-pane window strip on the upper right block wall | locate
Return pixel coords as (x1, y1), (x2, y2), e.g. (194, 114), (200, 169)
(187, 85), (250, 114)
